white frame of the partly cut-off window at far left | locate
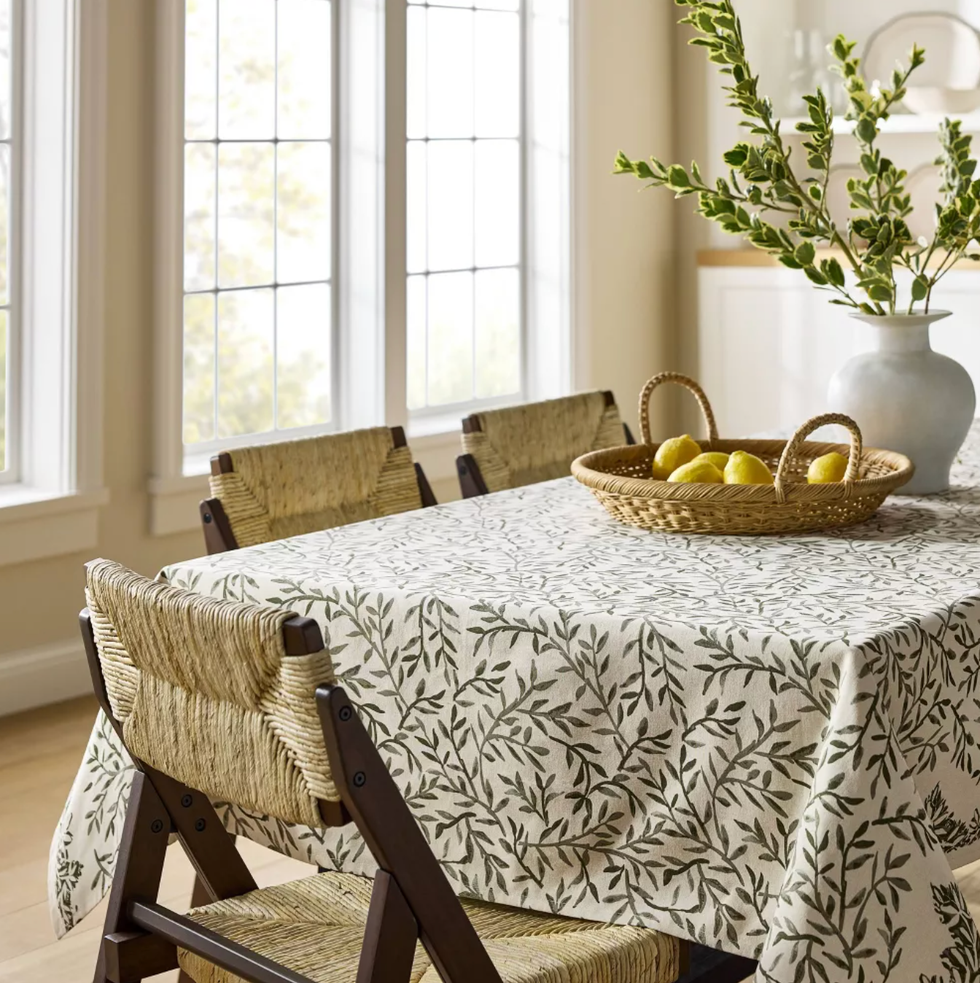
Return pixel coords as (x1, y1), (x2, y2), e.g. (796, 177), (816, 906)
(0, 0), (108, 565)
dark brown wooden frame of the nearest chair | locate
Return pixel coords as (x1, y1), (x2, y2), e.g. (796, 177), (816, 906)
(79, 609), (501, 983)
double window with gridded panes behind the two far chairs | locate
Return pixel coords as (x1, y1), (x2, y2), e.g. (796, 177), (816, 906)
(152, 0), (571, 492)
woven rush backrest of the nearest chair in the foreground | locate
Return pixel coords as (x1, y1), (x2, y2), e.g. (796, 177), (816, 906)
(86, 560), (339, 827)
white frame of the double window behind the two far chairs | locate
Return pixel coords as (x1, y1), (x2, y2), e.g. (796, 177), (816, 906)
(150, 0), (572, 535)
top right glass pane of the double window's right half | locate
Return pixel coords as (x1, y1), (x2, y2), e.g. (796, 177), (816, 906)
(474, 12), (521, 137)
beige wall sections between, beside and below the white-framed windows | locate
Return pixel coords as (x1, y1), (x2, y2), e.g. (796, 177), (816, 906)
(0, 0), (674, 708)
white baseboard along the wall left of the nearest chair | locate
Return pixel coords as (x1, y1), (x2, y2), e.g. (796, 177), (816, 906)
(0, 640), (92, 717)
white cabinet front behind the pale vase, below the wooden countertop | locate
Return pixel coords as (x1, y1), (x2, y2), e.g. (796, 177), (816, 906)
(698, 265), (980, 439)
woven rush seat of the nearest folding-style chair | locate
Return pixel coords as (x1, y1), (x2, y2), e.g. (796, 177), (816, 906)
(178, 873), (678, 983)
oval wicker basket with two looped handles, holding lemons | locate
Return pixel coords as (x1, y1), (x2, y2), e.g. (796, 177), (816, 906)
(572, 372), (915, 535)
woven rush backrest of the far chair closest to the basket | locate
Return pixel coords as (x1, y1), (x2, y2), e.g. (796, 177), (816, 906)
(456, 392), (631, 498)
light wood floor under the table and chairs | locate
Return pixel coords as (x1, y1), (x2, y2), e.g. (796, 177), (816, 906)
(0, 698), (980, 983)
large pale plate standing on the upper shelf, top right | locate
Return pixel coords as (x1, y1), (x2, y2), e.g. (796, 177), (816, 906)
(863, 10), (980, 89)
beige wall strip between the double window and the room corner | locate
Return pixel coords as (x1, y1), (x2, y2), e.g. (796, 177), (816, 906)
(573, 0), (676, 437)
